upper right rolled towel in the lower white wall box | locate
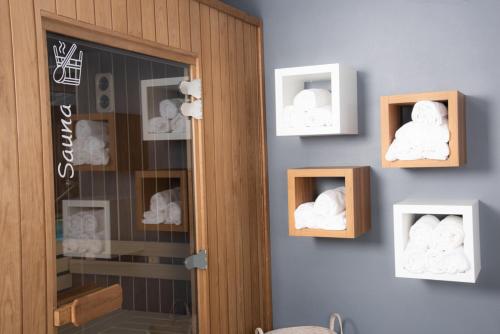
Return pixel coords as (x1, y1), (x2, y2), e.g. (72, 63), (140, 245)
(432, 216), (465, 251)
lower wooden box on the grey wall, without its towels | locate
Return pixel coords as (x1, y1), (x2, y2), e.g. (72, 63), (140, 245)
(288, 166), (371, 239)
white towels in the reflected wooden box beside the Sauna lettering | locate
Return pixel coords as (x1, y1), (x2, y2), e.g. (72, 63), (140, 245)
(73, 120), (109, 166)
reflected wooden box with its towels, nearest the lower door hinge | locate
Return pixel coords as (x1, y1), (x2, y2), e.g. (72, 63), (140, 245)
(135, 170), (189, 232)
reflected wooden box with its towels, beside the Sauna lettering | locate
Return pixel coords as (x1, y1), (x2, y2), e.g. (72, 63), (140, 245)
(71, 113), (143, 172)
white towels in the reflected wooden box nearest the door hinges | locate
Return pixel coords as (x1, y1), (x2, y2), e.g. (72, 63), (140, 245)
(142, 188), (182, 225)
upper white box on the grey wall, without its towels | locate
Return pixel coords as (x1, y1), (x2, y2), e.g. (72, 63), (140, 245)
(275, 64), (358, 136)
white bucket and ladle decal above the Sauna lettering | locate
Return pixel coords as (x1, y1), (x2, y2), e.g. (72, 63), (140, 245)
(52, 41), (83, 86)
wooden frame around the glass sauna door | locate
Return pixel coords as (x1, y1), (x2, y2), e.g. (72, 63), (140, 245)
(37, 10), (210, 334)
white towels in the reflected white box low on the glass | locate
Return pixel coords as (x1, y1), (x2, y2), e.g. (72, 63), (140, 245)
(63, 209), (106, 257)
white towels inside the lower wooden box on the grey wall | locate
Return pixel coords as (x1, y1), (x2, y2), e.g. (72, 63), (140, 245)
(294, 187), (346, 231)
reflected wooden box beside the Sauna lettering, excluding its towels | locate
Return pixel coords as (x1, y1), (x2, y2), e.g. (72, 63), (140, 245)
(71, 113), (147, 172)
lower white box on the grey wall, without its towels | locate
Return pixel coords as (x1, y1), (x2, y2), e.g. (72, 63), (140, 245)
(394, 200), (481, 283)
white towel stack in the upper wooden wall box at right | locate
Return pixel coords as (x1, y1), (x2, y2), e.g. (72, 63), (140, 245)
(385, 101), (450, 161)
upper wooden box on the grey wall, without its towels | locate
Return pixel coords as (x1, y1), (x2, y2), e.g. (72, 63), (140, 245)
(380, 90), (467, 168)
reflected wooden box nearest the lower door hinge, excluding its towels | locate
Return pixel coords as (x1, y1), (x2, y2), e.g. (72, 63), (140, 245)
(135, 170), (189, 232)
